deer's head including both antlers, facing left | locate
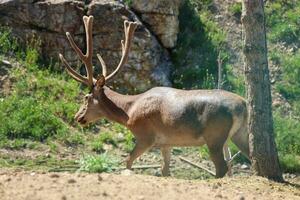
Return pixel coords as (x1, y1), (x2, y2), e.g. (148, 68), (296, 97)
(59, 16), (137, 125)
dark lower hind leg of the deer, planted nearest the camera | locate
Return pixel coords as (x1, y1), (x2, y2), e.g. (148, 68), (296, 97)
(208, 146), (228, 178)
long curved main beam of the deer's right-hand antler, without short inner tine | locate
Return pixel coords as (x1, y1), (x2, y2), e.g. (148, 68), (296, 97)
(105, 20), (137, 81)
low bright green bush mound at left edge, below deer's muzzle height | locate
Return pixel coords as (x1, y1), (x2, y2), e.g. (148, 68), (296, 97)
(0, 96), (68, 141)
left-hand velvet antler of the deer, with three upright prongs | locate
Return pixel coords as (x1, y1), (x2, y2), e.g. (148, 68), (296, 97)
(59, 16), (95, 87)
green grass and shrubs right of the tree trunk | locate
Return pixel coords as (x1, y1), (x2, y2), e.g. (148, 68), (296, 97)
(265, 0), (300, 172)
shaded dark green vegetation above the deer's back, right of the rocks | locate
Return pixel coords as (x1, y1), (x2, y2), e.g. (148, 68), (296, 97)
(172, 1), (225, 89)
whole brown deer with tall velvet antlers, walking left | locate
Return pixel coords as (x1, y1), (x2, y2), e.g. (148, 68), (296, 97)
(59, 16), (249, 178)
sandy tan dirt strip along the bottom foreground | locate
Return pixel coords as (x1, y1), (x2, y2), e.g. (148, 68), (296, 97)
(0, 169), (300, 200)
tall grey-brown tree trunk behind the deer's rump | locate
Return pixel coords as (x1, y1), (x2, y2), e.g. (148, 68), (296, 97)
(242, 0), (283, 182)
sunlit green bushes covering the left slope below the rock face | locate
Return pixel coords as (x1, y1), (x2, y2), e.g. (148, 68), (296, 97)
(0, 29), (80, 144)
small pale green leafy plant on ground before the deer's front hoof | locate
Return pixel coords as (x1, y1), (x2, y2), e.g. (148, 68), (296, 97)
(79, 154), (117, 173)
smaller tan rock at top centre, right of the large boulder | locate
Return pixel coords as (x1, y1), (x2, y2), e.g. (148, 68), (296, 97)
(131, 0), (182, 48)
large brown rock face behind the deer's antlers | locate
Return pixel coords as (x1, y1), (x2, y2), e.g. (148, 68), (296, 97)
(0, 0), (172, 93)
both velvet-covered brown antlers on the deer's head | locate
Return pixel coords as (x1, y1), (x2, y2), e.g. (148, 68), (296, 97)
(59, 16), (137, 87)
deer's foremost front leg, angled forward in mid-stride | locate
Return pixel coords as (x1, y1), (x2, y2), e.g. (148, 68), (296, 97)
(126, 141), (154, 169)
